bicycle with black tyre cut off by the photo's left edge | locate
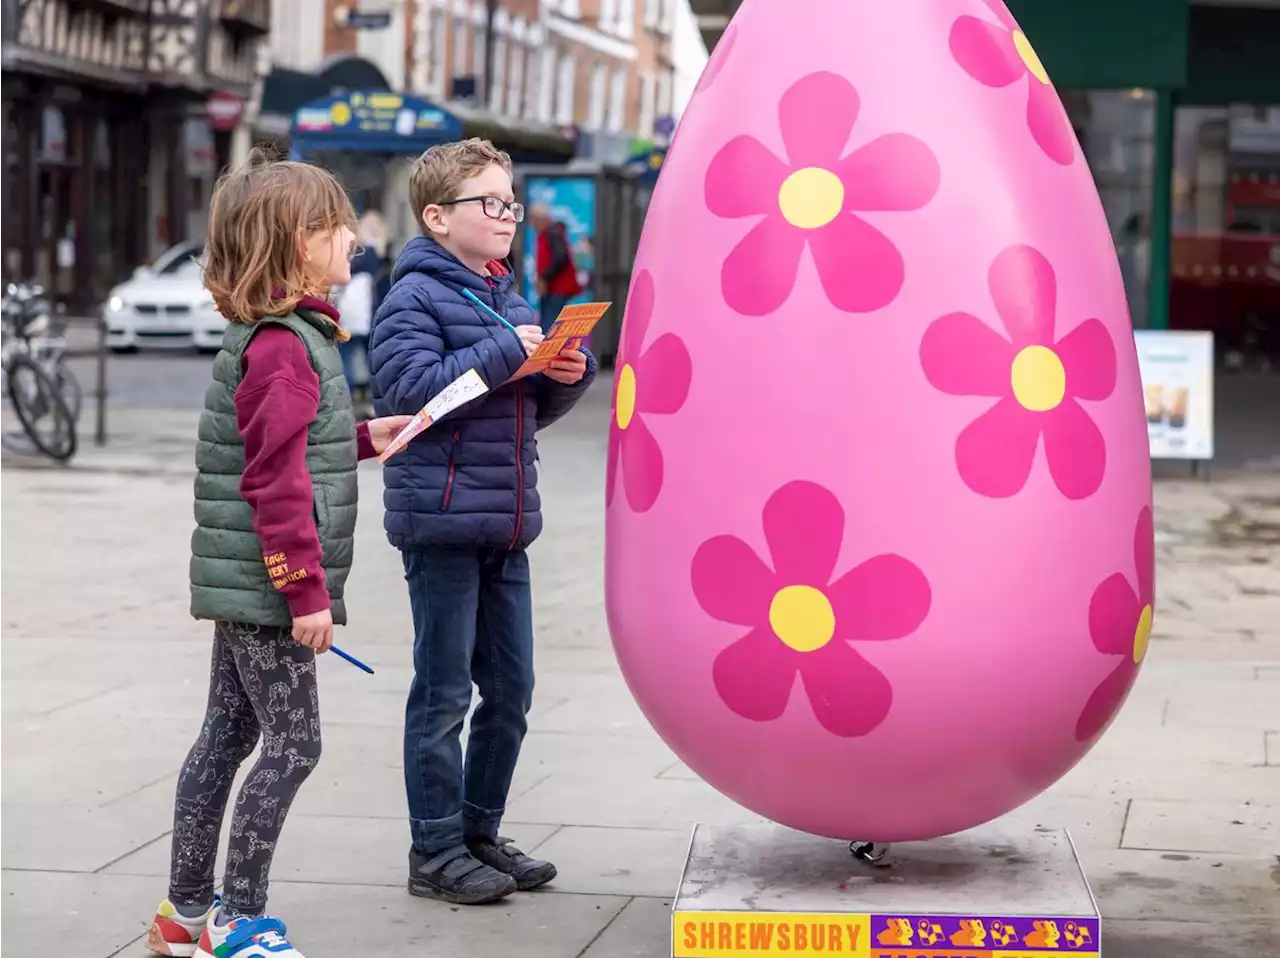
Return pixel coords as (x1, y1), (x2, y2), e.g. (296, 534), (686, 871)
(0, 289), (79, 462)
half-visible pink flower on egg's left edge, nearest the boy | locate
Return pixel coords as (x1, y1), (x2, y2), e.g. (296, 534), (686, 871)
(604, 269), (692, 512)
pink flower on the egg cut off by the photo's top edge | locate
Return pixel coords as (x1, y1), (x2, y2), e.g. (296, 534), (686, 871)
(951, 0), (1075, 166)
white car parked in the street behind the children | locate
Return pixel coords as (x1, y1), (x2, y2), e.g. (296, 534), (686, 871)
(102, 242), (227, 352)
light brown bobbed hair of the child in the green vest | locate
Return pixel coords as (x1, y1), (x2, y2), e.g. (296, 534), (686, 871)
(204, 150), (356, 323)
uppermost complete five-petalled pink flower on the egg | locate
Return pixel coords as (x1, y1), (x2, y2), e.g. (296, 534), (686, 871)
(704, 73), (941, 316)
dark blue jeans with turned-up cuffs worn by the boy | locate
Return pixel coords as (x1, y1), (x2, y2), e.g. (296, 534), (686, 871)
(403, 548), (534, 856)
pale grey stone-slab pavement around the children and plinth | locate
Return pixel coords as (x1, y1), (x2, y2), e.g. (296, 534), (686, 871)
(0, 361), (1280, 958)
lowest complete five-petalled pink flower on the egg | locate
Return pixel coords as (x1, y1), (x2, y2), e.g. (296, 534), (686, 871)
(691, 482), (932, 738)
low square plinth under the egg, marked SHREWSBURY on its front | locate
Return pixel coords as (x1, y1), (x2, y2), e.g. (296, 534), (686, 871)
(672, 825), (1102, 958)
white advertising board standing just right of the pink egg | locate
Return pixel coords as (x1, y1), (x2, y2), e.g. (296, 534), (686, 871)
(1134, 329), (1213, 460)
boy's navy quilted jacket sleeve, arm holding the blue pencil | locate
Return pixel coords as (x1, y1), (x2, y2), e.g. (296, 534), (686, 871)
(369, 276), (525, 416)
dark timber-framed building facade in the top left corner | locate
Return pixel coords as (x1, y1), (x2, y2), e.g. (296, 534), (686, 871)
(0, 0), (271, 310)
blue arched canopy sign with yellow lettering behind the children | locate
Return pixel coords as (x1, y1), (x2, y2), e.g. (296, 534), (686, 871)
(291, 91), (462, 156)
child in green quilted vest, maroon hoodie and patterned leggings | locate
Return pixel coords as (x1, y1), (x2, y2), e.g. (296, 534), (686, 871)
(147, 152), (408, 958)
